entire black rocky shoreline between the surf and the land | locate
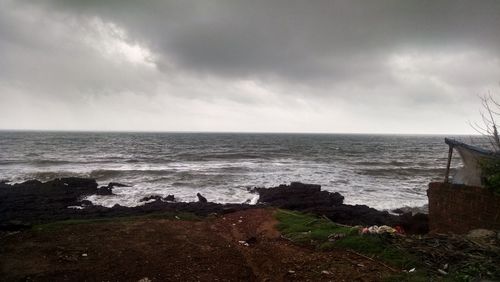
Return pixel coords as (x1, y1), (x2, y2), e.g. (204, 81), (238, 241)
(0, 177), (428, 234)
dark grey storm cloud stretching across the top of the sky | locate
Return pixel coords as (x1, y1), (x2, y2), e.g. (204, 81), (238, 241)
(42, 1), (500, 81)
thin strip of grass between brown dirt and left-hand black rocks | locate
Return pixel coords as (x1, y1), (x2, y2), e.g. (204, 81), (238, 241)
(32, 212), (200, 231)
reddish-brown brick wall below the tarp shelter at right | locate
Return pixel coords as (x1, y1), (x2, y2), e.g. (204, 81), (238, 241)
(427, 182), (500, 233)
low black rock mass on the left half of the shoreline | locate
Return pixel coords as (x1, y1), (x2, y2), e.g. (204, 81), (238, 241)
(0, 179), (255, 226)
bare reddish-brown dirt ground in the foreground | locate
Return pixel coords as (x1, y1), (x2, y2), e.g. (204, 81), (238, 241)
(0, 209), (398, 281)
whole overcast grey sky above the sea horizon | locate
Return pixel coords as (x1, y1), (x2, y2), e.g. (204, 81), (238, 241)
(0, 0), (500, 133)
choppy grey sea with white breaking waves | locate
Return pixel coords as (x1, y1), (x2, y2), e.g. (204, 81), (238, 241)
(0, 131), (468, 210)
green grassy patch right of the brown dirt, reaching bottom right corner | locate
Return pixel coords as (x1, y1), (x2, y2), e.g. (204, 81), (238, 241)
(276, 210), (500, 281)
